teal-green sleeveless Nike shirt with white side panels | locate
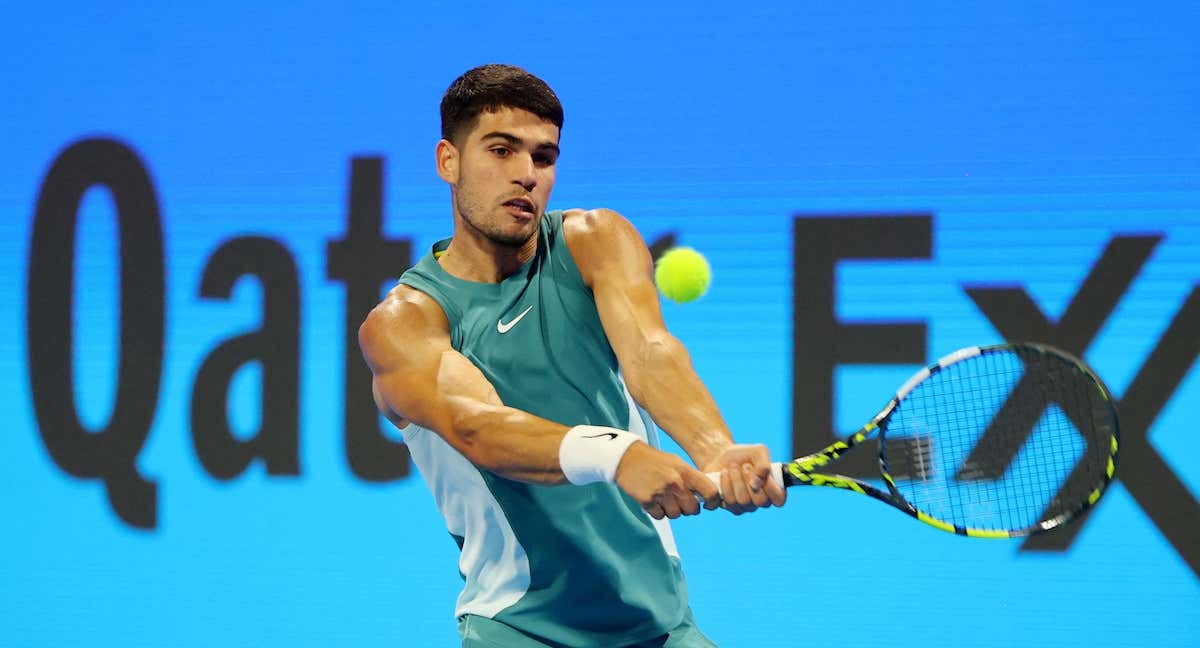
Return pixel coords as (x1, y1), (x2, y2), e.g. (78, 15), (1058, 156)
(400, 211), (688, 647)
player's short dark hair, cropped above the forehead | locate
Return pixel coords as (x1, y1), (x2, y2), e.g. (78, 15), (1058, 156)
(442, 64), (563, 142)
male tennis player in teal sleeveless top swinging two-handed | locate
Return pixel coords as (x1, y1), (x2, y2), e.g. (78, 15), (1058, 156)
(359, 65), (785, 648)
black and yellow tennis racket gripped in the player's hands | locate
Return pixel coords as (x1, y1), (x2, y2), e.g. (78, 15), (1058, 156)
(709, 343), (1117, 538)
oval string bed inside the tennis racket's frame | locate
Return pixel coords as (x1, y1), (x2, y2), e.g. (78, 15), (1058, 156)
(884, 348), (1111, 530)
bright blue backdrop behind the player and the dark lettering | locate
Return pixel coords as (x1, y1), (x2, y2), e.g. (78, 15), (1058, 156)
(0, 1), (1200, 648)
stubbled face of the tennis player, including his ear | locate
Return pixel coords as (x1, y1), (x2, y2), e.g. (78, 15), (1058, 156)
(439, 108), (558, 247)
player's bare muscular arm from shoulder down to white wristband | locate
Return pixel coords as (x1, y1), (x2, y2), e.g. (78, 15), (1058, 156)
(359, 286), (568, 484)
